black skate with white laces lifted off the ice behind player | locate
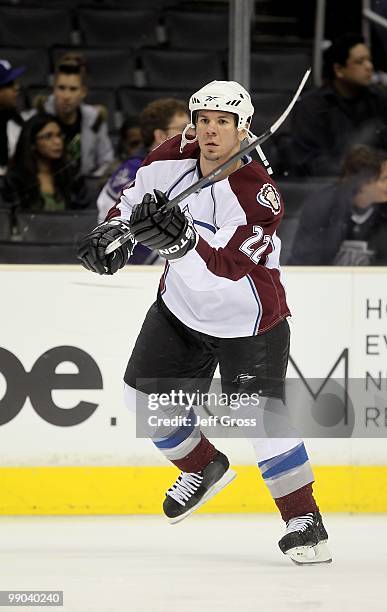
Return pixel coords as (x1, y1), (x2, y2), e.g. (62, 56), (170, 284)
(163, 451), (236, 523)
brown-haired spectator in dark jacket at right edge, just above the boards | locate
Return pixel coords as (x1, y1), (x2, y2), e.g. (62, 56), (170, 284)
(288, 145), (387, 266)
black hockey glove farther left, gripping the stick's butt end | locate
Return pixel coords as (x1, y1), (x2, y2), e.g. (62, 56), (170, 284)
(77, 219), (135, 274)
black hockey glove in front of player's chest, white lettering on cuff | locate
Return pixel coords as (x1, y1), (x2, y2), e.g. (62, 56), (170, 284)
(129, 189), (196, 259)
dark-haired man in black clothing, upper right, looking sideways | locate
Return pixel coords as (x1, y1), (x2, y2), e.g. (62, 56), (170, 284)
(289, 34), (387, 176)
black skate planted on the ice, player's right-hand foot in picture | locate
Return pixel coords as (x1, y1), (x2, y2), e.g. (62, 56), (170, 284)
(278, 512), (332, 565)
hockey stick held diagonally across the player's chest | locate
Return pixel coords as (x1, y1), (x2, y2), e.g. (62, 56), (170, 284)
(105, 68), (311, 255)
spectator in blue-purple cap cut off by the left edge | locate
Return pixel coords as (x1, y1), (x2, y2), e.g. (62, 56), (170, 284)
(0, 59), (25, 176)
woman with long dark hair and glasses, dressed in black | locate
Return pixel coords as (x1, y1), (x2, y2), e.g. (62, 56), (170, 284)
(3, 114), (91, 212)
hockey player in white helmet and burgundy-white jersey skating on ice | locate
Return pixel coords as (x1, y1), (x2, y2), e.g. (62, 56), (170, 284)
(78, 81), (331, 563)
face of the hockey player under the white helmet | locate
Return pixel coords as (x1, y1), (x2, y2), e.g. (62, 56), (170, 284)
(195, 110), (246, 165)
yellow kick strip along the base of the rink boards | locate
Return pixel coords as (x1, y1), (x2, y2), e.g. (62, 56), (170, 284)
(0, 465), (387, 515)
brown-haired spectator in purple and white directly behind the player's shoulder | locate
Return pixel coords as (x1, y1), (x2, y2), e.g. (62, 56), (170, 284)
(97, 98), (189, 263)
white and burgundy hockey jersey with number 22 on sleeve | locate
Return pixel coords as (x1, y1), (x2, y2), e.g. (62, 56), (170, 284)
(107, 136), (290, 338)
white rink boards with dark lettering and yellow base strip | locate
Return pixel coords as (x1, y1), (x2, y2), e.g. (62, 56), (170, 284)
(0, 266), (387, 514)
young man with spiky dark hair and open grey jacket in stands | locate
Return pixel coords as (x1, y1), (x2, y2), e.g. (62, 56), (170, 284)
(37, 53), (114, 177)
